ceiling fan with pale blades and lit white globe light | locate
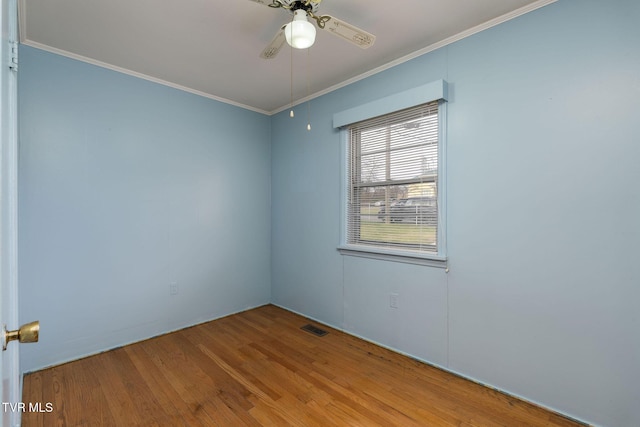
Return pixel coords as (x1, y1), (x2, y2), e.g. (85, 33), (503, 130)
(251, 0), (376, 59)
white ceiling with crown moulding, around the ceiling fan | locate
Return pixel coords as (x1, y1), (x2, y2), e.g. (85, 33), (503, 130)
(19, 0), (555, 114)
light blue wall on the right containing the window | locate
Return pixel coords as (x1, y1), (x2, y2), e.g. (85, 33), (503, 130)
(272, 0), (640, 426)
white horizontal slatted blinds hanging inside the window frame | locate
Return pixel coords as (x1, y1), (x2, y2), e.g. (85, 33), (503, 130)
(347, 102), (439, 253)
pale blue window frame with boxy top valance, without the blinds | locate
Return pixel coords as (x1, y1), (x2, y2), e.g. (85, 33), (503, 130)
(334, 80), (447, 269)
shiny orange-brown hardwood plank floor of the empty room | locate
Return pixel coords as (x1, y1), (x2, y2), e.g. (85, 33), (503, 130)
(22, 305), (581, 427)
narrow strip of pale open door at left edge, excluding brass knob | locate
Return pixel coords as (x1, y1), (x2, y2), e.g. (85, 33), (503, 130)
(0, 0), (21, 427)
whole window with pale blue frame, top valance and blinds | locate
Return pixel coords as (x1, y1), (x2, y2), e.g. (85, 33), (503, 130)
(333, 80), (447, 268)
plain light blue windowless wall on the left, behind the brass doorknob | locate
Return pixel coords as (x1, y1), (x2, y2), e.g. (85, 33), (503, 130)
(19, 46), (271, 371)
